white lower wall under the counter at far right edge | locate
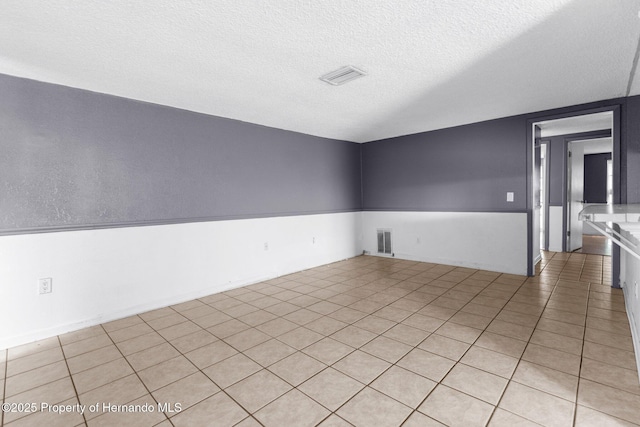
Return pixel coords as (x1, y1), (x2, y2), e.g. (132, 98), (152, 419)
(620, 232), (640, 378)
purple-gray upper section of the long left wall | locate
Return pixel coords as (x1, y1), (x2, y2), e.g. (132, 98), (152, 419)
(0, 75), (361, 233)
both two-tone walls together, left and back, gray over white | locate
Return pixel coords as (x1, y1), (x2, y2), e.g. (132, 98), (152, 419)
(0, 72), (640, 348)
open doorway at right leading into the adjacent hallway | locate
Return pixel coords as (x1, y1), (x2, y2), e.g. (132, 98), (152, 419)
(529, 107), (620, 276)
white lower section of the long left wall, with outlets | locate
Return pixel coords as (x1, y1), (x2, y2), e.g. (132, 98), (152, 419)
(0, 212), (362, 349)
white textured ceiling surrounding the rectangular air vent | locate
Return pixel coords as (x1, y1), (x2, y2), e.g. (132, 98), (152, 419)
(0, 0), (640, 142)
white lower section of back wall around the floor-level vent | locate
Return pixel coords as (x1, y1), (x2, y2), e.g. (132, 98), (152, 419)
(362, 212), (527, 275)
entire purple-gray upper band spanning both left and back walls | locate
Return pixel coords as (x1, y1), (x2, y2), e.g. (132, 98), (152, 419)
(0, 75), (640, 234)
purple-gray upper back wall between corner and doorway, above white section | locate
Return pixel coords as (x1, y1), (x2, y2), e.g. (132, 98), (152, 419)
(362, 116), (527, 212)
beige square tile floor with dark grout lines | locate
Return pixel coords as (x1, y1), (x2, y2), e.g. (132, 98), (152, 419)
(0, 253), (640, 427)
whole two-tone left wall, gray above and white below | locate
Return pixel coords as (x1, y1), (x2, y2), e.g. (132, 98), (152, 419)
(0, 75), (362, 348)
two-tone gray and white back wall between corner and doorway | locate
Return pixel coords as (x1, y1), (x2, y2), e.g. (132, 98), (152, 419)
(362, 117), (527, 274)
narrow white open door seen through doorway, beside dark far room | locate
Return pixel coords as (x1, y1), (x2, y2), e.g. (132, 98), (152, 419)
(567, 142), (584, 252)
